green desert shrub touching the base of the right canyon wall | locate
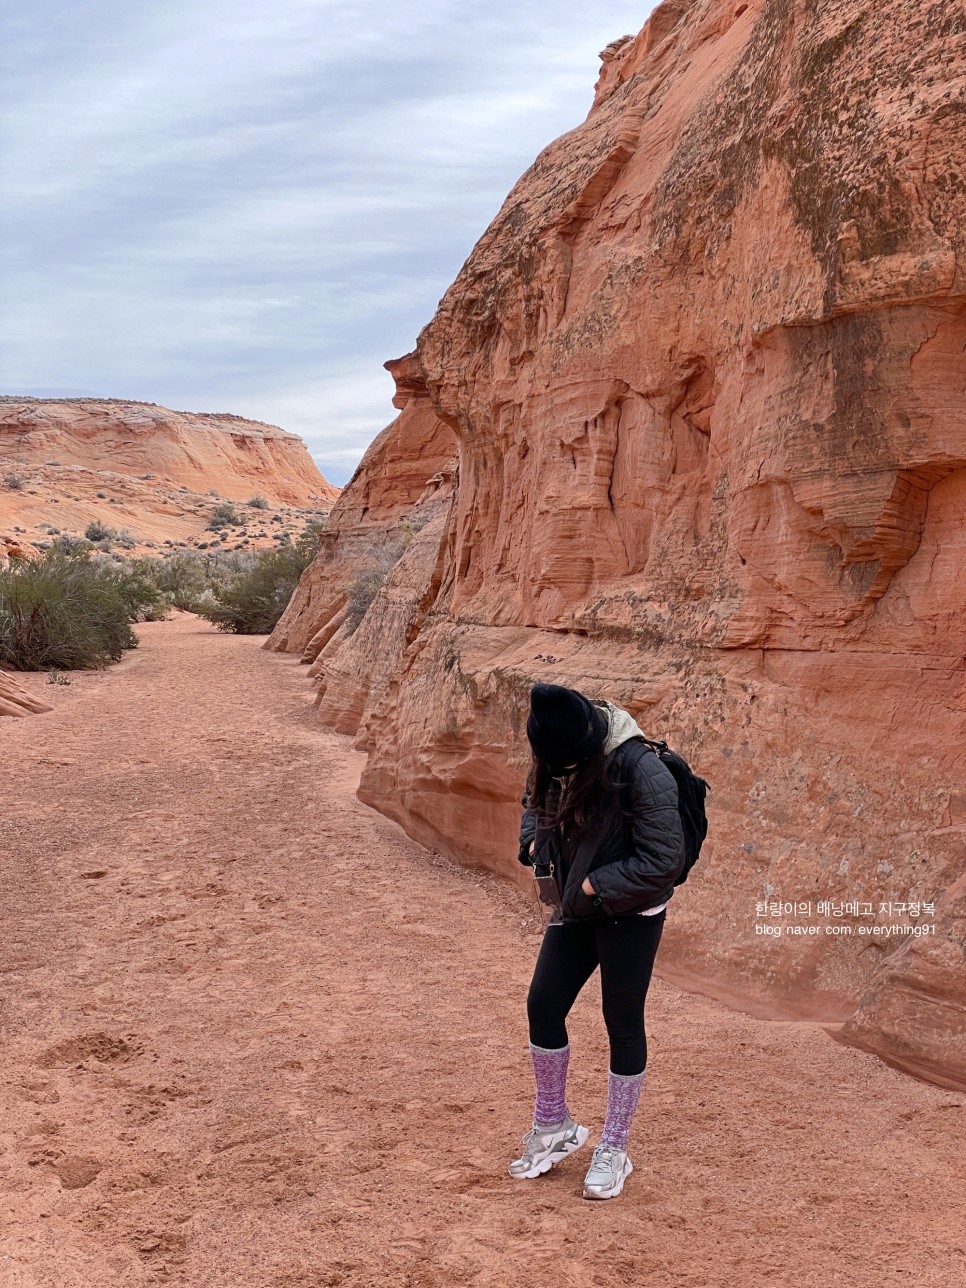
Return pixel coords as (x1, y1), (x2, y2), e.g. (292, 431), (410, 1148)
(196, 526), (321, 635)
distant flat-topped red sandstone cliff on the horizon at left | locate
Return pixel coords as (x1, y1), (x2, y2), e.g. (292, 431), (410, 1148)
(0, 397), (339, 547)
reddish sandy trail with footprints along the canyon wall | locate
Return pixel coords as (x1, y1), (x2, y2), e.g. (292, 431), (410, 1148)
(0, 617), (966, 1288)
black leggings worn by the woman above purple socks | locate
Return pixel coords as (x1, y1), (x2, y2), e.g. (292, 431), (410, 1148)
(527, 909), (667, 1074)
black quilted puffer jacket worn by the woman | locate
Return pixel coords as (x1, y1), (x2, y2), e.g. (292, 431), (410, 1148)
(518, 738), (684, 921)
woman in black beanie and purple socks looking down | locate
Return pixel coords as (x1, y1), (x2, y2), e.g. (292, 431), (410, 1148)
(510, 684), (684, 1199)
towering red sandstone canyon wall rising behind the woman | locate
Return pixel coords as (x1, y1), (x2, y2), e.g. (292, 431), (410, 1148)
(272, 0), (966, 1087)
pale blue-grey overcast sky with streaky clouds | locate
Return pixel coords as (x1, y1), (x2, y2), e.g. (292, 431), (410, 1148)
(0, 0), (654, 484)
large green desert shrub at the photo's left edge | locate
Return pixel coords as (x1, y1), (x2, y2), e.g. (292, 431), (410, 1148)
(0, 547), (160, 671)
